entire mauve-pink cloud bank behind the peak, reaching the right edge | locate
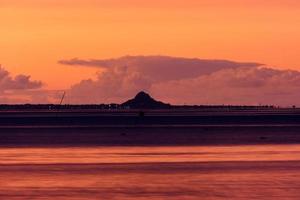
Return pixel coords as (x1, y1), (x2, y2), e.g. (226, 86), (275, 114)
(60, 56), (300, 105)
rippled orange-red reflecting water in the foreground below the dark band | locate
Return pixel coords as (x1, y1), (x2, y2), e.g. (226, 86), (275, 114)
(0, 144), (300, 200)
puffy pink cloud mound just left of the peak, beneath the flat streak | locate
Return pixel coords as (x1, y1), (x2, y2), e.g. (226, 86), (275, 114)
(67, 68), (155, 103)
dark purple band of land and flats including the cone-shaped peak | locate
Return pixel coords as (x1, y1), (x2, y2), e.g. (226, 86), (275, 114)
(0, 93), (300, 146)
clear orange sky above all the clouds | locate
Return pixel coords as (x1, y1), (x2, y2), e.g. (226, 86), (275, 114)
(0, 0), (300, 89)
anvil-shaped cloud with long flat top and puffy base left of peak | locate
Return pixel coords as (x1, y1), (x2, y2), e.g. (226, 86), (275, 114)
(59, 56), (260, 103)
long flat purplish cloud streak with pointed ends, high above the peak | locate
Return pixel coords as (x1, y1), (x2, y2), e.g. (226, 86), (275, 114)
(59, 56), (261, 81)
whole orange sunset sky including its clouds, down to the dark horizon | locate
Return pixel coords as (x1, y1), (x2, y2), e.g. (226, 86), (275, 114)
(0, 0), (300, 105)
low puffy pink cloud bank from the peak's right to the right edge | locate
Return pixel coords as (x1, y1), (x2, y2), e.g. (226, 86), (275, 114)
(151, 67), (300, 106)
